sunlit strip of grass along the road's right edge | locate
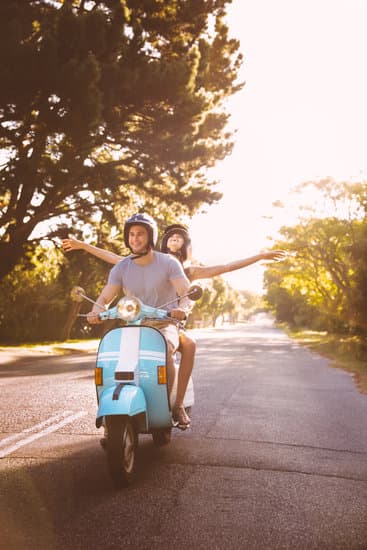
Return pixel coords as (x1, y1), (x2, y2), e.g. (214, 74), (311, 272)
(288, 326), (367, 394)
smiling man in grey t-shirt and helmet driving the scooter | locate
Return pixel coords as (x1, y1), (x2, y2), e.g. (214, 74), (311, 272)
(88, 214), (191, 429)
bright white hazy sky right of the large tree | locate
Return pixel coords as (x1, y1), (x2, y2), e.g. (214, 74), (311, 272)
(189, 0), (367, 292)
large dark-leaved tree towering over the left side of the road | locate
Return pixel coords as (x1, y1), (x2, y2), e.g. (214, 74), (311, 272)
(0, 0), (242, 280)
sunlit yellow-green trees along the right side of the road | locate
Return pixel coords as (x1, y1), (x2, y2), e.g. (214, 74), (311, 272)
(265, 179), (367, 334)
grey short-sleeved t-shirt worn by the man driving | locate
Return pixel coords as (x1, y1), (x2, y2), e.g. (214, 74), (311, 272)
(108, 252), (189, 311)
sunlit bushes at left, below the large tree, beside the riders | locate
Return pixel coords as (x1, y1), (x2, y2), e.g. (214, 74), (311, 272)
(0, 243), (115, 344)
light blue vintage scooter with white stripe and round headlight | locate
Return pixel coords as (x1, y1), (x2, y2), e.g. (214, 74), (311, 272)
(71, 285), (202, 488)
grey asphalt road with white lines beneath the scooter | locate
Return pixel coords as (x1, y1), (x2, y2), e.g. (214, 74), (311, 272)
(0, 321), (367, 550)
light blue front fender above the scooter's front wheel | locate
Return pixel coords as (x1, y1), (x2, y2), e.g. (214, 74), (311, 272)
(96, 384), (148, 428)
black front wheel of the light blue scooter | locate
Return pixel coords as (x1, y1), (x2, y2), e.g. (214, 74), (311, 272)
(106, 416), (137, 489)
